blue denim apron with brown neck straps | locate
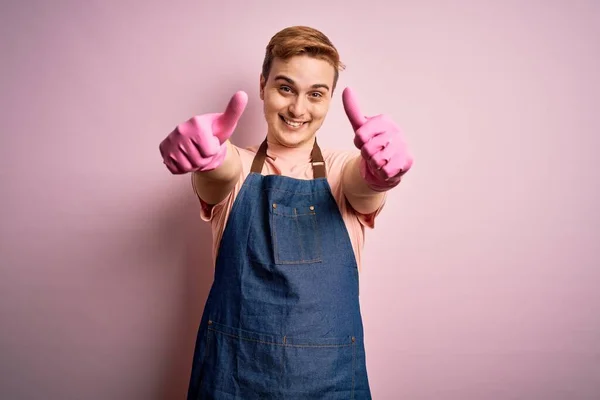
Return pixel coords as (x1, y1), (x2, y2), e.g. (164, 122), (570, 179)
(188, 140), (371, 400)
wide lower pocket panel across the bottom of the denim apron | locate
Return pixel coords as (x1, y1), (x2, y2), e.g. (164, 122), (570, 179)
(204, 322), (357, 400)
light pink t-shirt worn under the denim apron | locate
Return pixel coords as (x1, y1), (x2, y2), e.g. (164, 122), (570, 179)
(195, 142), (385, 269)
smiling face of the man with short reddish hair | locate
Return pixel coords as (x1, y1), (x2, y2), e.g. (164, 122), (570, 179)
(260, 55), (335, 147)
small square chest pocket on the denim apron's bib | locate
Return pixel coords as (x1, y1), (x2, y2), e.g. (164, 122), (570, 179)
(271, 203), (322, 264)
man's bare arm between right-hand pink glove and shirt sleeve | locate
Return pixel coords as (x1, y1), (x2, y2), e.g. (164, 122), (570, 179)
(342, 155), (385, 214)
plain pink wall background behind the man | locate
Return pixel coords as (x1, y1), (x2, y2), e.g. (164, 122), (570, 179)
(0, 0), (600, 400)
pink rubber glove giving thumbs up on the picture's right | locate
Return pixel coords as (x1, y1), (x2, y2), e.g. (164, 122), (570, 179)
(342, 88), (413, 192)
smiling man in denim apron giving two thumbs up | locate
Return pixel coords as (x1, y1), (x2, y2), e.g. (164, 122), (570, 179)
(160, 26), (412, 399)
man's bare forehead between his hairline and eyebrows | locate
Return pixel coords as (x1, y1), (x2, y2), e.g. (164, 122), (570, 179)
(269, 55), (335, 87)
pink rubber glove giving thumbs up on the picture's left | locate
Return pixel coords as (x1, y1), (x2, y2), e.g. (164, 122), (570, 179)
(159, 91), (248, 174)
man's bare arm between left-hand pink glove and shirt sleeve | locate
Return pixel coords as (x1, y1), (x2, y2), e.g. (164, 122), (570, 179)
(192, 140), (242, 204)
